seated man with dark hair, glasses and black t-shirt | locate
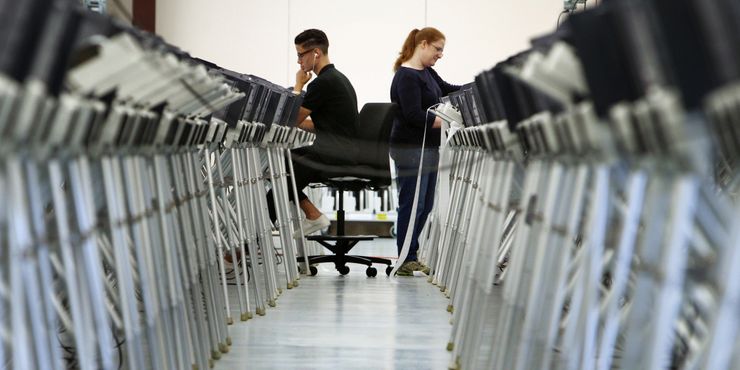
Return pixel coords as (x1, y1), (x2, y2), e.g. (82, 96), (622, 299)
(267, 29), (358, 238)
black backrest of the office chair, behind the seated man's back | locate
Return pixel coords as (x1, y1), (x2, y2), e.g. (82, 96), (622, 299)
(356, 103), (398, 179)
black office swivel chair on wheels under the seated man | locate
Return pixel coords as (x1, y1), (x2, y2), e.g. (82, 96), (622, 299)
(298, 103), (398, 277)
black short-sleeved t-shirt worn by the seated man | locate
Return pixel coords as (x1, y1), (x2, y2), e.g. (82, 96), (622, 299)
(302, 64), (359, 164)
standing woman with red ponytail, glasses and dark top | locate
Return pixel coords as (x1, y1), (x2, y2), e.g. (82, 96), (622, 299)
(390, 27), (460, 276)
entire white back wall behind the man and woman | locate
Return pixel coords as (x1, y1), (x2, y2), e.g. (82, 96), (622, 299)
(156, 0), (562, 106)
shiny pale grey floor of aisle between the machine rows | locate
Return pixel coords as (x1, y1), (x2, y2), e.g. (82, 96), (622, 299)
(215, 239), (451, 369)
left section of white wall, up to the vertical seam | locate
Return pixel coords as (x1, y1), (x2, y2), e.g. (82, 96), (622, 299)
(156, 0), (288, 84)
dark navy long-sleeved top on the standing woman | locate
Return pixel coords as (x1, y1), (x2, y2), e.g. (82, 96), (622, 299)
(391, 67), (460, 148)
